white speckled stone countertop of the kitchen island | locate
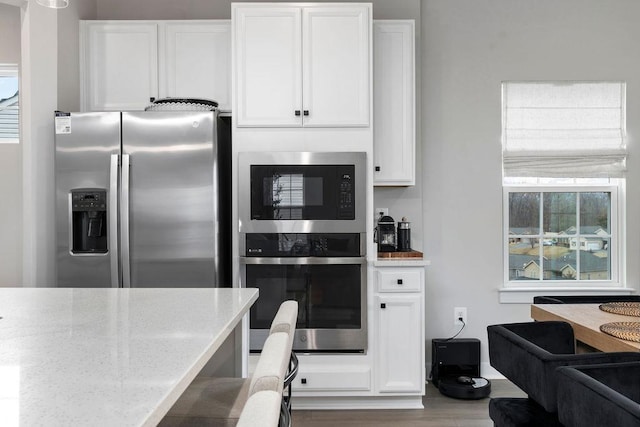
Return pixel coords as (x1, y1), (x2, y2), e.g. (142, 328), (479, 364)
(0, 288), (258, 426)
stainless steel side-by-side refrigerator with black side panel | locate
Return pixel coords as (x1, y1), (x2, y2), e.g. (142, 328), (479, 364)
(55, 111), (230, 287)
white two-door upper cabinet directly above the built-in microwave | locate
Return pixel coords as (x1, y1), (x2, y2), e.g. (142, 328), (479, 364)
(232, 3), (371, 127)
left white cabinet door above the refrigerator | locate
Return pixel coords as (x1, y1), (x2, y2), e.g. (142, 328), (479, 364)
(81, 21), (158, 111)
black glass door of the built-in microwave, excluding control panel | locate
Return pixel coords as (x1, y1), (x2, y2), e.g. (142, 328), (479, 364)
(251, 165), (339, 220)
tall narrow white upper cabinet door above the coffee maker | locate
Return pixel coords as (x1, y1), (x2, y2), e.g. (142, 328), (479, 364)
(373, 20), (415, 185)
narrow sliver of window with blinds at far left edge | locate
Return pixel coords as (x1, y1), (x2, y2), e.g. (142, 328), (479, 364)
(0, 64), (20, 144)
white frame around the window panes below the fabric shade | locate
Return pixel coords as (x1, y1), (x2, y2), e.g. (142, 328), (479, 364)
(502, 179), (626, 293)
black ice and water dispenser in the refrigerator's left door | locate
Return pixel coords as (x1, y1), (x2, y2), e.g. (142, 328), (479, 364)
(71, 188), (107, 254)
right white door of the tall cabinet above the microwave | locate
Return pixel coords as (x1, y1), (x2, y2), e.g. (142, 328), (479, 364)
(302, 5), (371, 127)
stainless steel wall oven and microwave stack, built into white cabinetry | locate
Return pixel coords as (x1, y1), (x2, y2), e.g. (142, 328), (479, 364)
(238, 152), (367, 352)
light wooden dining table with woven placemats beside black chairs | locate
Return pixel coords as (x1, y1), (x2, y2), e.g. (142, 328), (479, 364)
(531, 304), (640, 352)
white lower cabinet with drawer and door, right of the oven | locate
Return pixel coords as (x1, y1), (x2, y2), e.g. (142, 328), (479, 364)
(374, 263), (425, 395)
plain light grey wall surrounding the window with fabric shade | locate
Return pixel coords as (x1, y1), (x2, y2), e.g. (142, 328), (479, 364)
(421, 0), (640, 368)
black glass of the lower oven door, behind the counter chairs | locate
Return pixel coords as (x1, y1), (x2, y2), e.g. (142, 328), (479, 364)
(247, 264), (363, 329)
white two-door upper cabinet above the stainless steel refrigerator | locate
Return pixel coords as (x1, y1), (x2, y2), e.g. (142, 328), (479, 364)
(80, 20), (231, 111)
